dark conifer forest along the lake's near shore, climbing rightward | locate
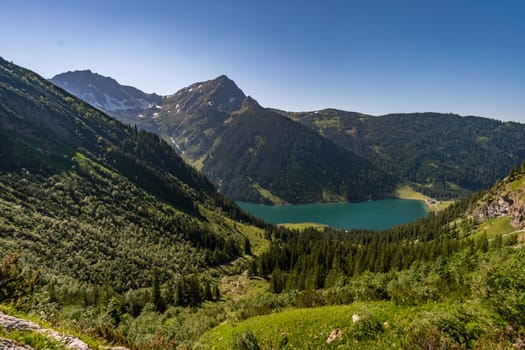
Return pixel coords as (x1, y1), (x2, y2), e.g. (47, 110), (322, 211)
(250, 194), (488, 293)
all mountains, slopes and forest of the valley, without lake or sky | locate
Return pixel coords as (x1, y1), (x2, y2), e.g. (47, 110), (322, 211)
(0, 59), (525, 350)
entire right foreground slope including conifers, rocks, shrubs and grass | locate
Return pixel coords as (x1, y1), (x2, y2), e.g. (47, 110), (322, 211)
(200, 163), (525, 349)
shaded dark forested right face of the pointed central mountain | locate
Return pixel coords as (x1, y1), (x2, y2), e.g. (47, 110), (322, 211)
(202, 98), (394, 203)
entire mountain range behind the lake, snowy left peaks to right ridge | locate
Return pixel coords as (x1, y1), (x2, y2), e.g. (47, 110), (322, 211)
(51, 71), (525, 204)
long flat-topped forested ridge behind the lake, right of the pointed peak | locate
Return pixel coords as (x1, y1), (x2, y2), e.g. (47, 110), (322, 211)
(279, 109), (525, 198)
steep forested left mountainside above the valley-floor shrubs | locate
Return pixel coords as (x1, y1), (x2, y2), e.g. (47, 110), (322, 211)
(0, 59), (258, 292)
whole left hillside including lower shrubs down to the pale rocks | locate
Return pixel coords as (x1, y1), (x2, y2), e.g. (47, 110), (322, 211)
(0, 60), (274, 348)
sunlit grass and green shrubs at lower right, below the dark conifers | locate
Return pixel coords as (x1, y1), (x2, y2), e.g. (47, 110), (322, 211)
(199, 248), (525, 349)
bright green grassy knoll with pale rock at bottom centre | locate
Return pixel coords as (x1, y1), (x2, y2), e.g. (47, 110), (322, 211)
(201, 302), (504, 350)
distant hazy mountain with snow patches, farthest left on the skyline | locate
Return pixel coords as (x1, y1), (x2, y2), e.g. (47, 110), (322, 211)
(50, 70), (162, 130)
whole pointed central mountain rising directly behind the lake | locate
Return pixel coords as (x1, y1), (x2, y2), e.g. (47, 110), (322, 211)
(52, 73), (395, 203)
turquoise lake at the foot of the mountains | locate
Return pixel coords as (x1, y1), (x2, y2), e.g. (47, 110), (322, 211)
(237, 199), (428, 230)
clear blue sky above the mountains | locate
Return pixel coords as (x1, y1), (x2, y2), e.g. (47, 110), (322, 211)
(0, 0), (525, 122)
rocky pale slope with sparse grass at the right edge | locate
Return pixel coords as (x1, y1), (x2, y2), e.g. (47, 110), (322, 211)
(474, 163), (525, 230)
